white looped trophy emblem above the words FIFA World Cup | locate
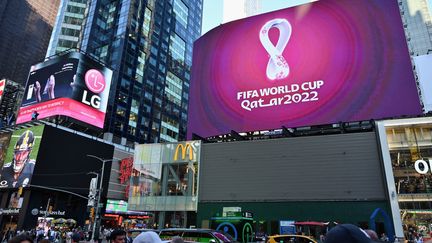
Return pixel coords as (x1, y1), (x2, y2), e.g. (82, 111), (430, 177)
(260, 19), (292, 81)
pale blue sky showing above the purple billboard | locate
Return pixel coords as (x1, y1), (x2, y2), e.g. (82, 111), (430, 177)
(201, 0), (432, 34)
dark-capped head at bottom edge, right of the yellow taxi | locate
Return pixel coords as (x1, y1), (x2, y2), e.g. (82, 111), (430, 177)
(324, 224), (376, 243)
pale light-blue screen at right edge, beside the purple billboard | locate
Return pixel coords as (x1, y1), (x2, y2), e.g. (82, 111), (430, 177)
(414, 55), (432, 112)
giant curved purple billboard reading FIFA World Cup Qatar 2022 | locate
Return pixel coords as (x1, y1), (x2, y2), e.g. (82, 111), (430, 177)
(188, 0), (421, 138)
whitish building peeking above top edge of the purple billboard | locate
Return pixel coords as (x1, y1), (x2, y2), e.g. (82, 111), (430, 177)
(223, 0), (261, 23)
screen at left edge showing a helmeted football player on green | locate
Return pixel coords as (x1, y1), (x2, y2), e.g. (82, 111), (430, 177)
(0, 125), (44, 188)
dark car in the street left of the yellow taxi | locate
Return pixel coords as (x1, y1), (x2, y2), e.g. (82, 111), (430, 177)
(159, 228), (236, 243)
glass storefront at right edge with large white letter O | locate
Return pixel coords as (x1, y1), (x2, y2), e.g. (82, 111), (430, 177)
(377, 117), (432, 240)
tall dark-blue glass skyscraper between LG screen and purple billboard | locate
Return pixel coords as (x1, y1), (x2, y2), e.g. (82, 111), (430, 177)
(81, 0), (202, 143)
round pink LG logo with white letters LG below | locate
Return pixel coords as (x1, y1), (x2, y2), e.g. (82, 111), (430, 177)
(82, 69), (106, 109)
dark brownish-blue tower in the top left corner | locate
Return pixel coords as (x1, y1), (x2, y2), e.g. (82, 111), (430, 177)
(0, 0), (60, 84)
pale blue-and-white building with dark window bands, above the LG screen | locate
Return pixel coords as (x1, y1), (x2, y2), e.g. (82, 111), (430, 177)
(46, 0), (89, 57)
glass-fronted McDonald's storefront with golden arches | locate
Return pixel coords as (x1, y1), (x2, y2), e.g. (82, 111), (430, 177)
(128, 141), (201, 228)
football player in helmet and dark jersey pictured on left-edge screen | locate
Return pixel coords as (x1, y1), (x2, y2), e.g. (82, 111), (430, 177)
(0, 130), (36, 188)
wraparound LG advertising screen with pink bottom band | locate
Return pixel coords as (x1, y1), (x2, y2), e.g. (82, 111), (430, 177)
(17, 52), (112, 128)
